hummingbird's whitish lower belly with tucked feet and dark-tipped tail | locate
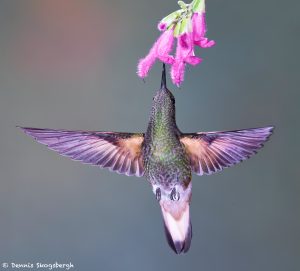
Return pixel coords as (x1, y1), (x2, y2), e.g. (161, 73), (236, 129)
(152, 182), (192, 254)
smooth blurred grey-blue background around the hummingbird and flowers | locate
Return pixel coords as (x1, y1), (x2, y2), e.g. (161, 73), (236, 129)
(0, 0), (300, 271)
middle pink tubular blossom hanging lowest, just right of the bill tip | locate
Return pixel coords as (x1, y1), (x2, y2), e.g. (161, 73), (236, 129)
(171, 33), (202, 86)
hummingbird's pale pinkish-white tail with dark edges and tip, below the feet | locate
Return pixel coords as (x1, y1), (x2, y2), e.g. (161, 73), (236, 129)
(161, 202), (192, 254)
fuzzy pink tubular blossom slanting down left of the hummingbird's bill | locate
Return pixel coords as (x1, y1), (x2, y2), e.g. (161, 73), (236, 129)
(137, 29), (174, 78)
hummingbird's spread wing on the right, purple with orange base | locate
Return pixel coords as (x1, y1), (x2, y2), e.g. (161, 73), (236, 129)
(180, 126), (274, 175)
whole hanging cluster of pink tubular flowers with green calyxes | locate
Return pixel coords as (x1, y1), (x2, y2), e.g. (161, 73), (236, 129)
(137, 0), (215, 86)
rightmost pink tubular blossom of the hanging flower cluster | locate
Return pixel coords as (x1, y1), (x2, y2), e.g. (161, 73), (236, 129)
(192, 12), (215, 48)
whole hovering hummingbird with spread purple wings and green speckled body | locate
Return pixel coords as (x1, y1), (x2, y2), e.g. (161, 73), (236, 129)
(20, 65), (274, 254)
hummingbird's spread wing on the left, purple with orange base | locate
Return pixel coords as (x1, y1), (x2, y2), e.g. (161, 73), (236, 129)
(20, 127), (144, 177)
